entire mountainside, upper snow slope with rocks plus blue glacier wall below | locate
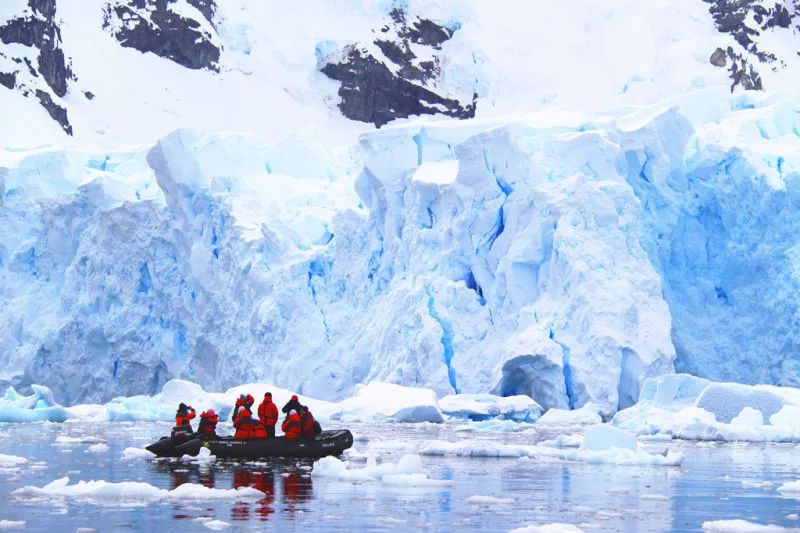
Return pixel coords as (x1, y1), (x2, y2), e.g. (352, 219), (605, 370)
(0, 0), (800, 414)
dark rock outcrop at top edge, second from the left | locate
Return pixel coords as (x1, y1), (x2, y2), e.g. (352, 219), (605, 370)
(103, 0), (222, 72)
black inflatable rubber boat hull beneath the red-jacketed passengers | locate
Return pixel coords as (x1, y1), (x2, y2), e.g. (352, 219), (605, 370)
(147, 429), (353, 459)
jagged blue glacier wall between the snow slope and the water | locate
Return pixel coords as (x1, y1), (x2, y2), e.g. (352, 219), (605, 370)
(0, 91), (800, 415)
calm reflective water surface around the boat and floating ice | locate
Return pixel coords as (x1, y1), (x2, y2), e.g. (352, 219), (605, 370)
(0, 422), (800, 532)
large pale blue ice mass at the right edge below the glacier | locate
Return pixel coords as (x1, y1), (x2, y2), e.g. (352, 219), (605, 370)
(612, 374), (800, 442)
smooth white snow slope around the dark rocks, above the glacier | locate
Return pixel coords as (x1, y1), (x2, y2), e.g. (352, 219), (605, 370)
(0, 0), (764, 148)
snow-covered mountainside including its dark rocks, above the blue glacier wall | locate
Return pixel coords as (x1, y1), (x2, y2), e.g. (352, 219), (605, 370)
(0, 0), (800, 147)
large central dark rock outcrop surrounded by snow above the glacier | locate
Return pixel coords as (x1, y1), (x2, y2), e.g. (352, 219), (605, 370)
(320, 9), (477, 127)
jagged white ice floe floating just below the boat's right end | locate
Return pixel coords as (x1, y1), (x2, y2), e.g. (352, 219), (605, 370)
(311, 454), (453, 487)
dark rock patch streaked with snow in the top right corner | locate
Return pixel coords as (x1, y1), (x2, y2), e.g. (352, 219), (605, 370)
(703, 0), (800, 90)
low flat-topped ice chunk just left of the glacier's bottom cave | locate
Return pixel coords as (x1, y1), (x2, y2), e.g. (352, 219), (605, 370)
(439, 394), (543, 422)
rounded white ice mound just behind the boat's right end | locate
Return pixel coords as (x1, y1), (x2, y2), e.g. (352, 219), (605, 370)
(332, 381), (444, 422)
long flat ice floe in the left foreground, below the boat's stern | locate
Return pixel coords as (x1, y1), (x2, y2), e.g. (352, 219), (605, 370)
(11, 477), (264, 504)
